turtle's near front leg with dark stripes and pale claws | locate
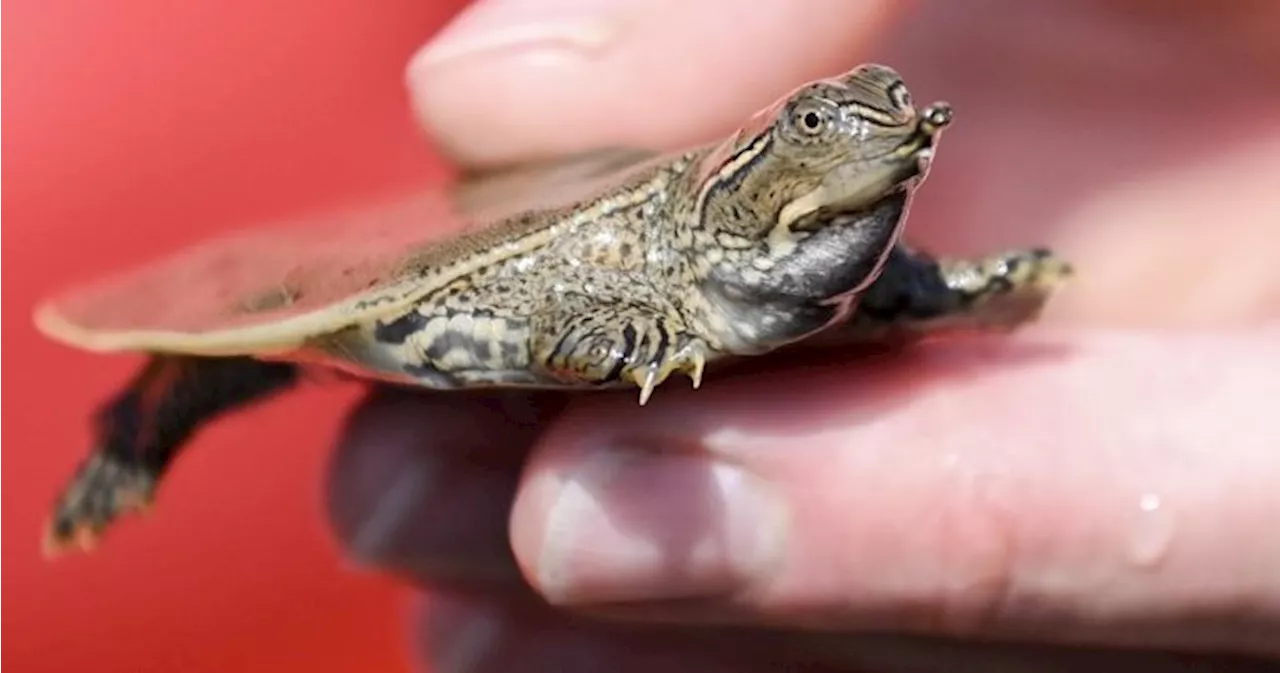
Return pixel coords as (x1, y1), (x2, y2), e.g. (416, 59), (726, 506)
(530, 285), (709, 404)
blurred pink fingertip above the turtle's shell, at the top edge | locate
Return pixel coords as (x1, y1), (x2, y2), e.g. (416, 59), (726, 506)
(408, 0), (901, 165)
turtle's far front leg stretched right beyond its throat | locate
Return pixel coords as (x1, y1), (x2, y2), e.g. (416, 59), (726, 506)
(838, 246), (1073, 342)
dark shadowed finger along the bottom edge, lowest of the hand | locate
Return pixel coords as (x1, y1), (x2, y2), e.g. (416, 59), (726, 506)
(412, 591), (1271, 673)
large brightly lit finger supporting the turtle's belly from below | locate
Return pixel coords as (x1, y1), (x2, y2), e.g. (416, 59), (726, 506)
(512, 330), (1280, 653)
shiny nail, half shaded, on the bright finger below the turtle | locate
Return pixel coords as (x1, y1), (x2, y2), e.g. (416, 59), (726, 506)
(536, 449), (787, 604)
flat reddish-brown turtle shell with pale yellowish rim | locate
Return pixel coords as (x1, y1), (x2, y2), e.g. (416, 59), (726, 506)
(35, 150), (649, 356)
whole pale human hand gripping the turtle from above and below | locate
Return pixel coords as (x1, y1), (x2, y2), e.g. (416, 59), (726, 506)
(329, 0), (1280, 673)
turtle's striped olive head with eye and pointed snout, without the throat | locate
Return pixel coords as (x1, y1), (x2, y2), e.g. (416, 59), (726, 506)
(698, 64), (951, 235)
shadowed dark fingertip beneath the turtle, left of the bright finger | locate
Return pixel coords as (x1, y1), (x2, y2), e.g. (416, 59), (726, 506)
(328, 390), (558, 582)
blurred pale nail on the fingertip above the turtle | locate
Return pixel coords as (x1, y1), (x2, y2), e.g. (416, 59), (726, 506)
(412, 0), (620, 69)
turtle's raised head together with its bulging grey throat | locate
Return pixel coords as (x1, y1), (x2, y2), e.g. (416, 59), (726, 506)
(692, 65), (951, 353)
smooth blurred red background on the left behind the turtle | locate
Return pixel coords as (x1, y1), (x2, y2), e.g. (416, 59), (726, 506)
(0, 0), (465, 673)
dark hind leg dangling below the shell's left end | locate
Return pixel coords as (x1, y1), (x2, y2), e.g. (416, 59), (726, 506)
(45, 356), (298, 554)
